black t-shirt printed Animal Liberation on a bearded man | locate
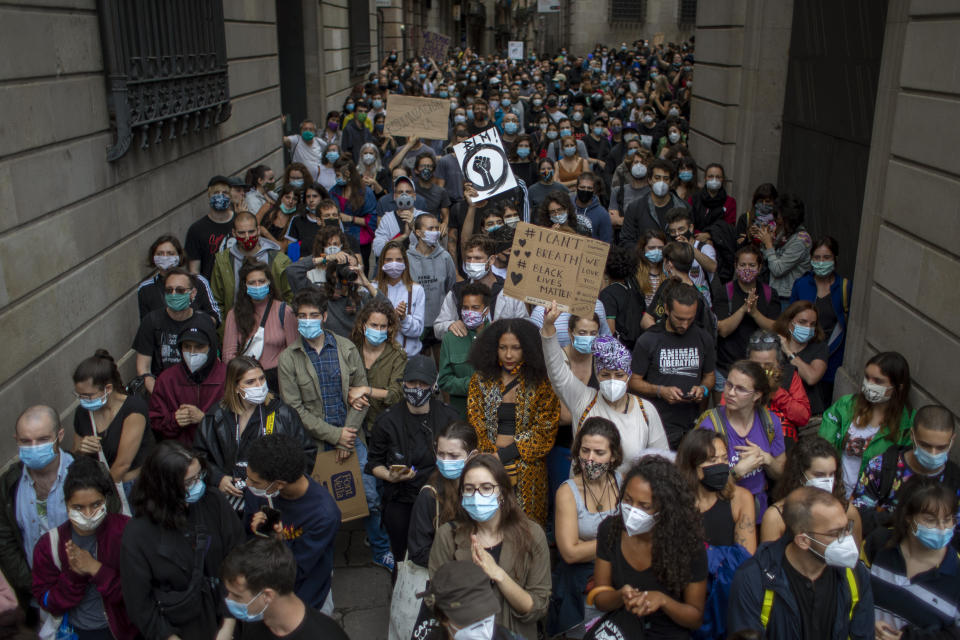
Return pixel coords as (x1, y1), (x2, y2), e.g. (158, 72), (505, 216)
(632, 322), (717, 446)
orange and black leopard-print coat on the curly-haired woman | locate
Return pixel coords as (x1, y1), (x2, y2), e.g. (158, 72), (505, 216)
(467, 373), (560, 525)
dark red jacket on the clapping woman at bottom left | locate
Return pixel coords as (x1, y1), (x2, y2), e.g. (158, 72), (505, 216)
(33, 513), (140, 640)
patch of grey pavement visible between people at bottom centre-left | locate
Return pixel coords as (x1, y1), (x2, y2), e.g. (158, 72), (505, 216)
(333, 520), (393, 640)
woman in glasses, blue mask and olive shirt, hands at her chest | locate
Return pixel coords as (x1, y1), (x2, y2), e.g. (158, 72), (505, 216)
(428, 454), (550, 638)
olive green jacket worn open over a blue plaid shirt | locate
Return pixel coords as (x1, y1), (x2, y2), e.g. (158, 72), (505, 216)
(277, 333), (367, 448)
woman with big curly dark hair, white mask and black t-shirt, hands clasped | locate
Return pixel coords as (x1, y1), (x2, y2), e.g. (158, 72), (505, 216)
(587, 456), (707, 639)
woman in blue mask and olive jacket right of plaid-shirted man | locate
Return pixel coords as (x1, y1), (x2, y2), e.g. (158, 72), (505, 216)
(350, 298), (407, 431)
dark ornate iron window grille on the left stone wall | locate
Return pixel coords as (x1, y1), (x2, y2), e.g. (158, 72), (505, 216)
(98, 0), (230, 162)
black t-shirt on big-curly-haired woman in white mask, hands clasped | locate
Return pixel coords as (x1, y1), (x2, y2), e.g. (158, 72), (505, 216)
(597, 515), (707, 640)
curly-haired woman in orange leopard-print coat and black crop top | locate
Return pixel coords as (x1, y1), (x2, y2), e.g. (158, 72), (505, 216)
(467, 318), (560, 525)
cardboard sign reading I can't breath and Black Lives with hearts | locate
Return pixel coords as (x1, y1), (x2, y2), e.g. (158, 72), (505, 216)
(503, 222), (608, 322)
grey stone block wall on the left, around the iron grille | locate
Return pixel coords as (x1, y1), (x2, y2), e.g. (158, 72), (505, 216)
(0, 0), (379, 460)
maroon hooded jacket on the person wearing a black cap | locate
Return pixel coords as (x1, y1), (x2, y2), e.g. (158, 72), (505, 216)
(150, 360), (227, 447)
